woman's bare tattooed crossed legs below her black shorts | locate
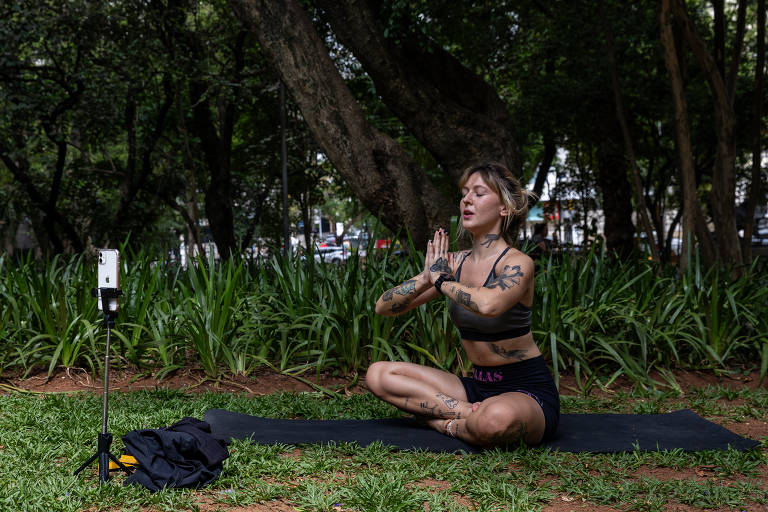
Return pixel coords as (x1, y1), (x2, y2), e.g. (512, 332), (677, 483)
(365, 361), (545, 446)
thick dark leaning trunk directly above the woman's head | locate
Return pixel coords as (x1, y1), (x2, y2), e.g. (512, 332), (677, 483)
(318, 0), (522, 181)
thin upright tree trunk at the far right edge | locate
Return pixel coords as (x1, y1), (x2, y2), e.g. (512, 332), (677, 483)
(742, 0), (765, 263)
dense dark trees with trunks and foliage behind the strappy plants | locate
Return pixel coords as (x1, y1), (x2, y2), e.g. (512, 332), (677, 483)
(0, 0), (766, 264)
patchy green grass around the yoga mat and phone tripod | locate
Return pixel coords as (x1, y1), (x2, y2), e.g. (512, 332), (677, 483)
(0, 387), (768, 511)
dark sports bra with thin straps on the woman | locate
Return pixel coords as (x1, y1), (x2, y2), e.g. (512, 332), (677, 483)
(448, 247), (531, 341)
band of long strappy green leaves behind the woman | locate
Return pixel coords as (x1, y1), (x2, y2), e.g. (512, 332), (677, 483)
(0, 244), (768, 389)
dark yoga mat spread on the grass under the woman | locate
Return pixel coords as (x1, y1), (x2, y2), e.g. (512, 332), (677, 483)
(205, 409), (760, 453)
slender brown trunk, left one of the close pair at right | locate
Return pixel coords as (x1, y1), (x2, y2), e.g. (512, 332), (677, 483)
(659, 0), (712, 272)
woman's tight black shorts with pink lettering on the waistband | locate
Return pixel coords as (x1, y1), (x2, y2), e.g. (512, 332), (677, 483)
(459, 356), (560, 442)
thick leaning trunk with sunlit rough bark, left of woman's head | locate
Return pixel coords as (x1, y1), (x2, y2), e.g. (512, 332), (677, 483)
(231, 0), (454, 247)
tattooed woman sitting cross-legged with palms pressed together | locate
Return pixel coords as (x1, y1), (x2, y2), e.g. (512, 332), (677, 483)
(365, 164), (560, 447)
